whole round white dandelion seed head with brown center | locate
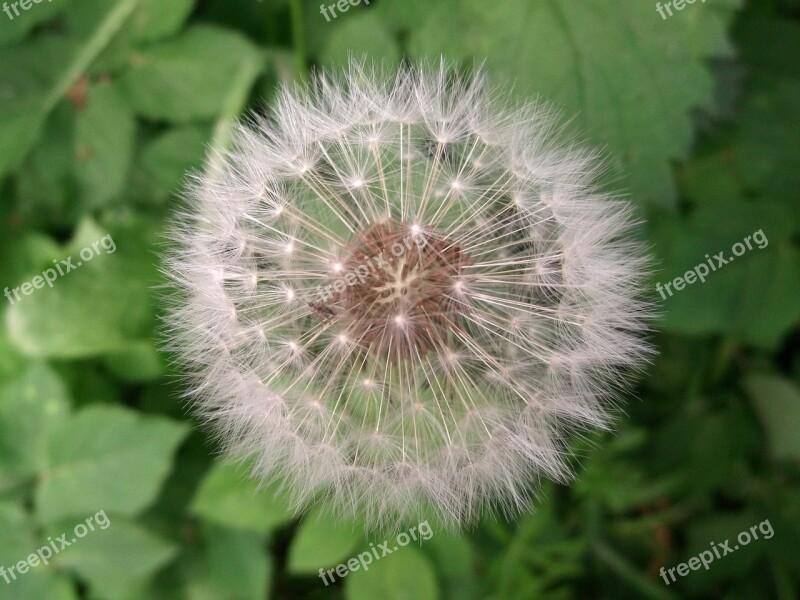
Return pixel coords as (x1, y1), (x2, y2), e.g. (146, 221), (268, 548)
(167, 62), (650, 527)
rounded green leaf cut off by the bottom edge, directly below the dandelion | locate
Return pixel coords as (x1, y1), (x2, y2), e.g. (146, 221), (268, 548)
(345, 546), (439, 600)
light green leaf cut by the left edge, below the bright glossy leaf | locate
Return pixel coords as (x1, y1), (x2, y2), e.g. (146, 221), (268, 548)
(0, 364), (70, 475)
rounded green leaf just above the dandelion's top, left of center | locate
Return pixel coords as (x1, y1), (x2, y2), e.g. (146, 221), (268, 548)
(322, 11), (400, 66)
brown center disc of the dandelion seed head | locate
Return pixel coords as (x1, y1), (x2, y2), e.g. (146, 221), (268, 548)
(312, 221), (468, 359)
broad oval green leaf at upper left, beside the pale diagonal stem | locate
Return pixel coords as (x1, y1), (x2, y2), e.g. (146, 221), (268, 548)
(120, 25), (263, 123)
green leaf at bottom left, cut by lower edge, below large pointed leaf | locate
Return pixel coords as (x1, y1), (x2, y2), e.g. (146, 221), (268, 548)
(50, 516), (177, 600)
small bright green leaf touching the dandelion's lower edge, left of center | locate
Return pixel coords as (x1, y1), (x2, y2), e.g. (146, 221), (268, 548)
(288, 510), (364, 574)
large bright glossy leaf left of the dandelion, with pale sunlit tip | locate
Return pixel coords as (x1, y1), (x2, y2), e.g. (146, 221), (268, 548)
(6, 221), (158, 358)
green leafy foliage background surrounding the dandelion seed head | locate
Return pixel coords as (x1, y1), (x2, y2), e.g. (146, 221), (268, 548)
(0, 0), (800, 600)
